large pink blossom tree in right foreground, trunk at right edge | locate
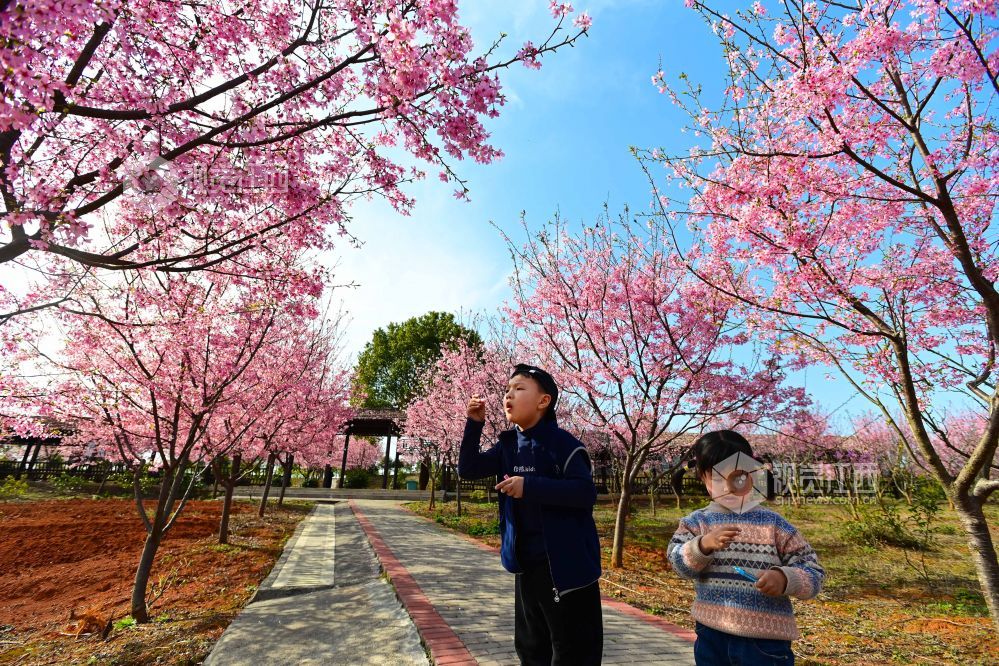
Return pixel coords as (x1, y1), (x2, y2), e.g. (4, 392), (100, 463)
(641, 0), (999, 627)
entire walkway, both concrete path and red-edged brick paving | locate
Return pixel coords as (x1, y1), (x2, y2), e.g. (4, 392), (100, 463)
(205, 500), (693, 666)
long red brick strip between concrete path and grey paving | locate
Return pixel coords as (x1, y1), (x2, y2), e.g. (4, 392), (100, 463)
(349, 500), (478, 666)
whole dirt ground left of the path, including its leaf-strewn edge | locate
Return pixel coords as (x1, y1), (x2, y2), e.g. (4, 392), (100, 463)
(0, 499), (307, 664)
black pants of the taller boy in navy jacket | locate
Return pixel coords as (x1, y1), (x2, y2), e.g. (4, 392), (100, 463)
(514, 562), (604, 666)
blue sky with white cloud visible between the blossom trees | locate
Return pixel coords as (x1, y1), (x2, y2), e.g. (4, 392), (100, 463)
(326, 0), (866, 422)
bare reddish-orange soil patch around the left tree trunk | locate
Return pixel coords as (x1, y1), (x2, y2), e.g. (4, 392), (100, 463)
(0, 500), (300, 635)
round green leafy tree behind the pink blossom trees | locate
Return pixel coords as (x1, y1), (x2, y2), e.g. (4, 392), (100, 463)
(354, 312), (482, 409)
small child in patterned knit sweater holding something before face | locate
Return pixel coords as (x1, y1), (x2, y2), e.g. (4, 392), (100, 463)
(667, 430), (825, 666)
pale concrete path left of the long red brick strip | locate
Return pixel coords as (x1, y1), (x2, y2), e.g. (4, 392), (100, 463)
(205, 503), (429, 666)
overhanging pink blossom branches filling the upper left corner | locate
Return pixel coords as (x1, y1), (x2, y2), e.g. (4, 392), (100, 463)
(0, 0), (590, 318)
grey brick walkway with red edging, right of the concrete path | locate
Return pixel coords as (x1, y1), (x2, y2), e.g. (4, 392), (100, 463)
(351, 500), (694, 666)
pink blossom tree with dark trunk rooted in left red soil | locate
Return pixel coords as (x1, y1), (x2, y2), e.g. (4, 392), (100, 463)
(24, 272), (317, 622)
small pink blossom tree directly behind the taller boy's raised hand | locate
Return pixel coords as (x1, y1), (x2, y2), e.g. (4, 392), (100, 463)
(400, 338), (512, 512)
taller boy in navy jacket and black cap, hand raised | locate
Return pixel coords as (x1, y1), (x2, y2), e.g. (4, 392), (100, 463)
(458, 364), (603, 666)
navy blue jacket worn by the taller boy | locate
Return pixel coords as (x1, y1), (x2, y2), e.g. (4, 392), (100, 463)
(458, 419), (600, 595)
